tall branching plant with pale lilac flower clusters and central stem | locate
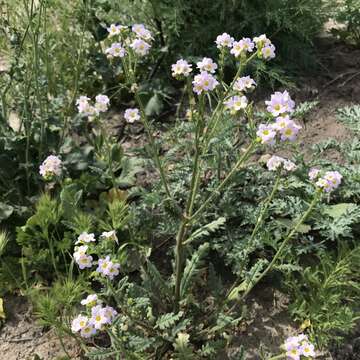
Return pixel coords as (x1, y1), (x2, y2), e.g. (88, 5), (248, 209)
(42, 24), (342, 358)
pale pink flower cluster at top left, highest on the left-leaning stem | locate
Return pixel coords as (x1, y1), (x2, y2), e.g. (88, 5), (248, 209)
(105, 24), (153, 59)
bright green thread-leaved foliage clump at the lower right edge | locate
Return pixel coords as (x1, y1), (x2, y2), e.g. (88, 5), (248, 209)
(287, 246), (360, 346)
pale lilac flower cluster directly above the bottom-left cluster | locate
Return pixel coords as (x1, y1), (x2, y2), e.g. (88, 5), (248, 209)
(73, 230), (120, 280)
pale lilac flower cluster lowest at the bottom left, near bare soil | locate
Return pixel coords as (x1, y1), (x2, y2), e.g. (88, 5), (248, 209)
(71, 294), (117, 338)
